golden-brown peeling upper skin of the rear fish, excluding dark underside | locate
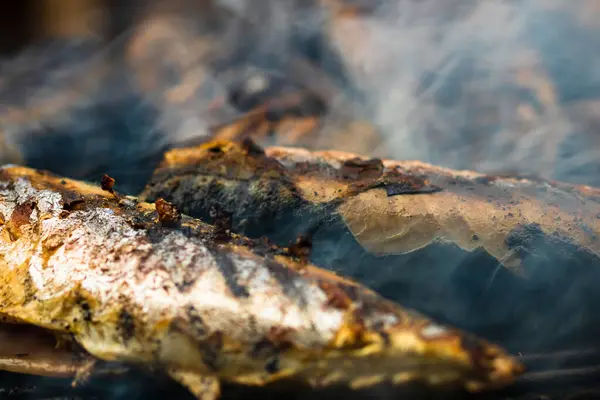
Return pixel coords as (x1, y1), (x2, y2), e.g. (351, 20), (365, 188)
(141, 141), (600, 271)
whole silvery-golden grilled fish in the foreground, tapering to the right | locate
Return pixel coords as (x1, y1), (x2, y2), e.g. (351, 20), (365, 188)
(0, 166), (522, 398)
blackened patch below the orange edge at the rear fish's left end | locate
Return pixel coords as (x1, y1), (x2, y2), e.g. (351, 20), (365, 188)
(143, 161), (322, 246)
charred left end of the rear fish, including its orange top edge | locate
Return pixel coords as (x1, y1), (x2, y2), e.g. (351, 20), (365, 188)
(140, 140), (335, 245)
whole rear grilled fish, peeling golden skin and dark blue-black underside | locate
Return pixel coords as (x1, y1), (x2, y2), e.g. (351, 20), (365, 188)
(141, 141), (600, 352)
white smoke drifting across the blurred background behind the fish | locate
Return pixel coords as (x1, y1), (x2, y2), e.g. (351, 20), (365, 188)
(0, 0), (600, 185)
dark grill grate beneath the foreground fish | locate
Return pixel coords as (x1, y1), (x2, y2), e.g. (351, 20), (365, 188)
(0, 349), (600, 400)
